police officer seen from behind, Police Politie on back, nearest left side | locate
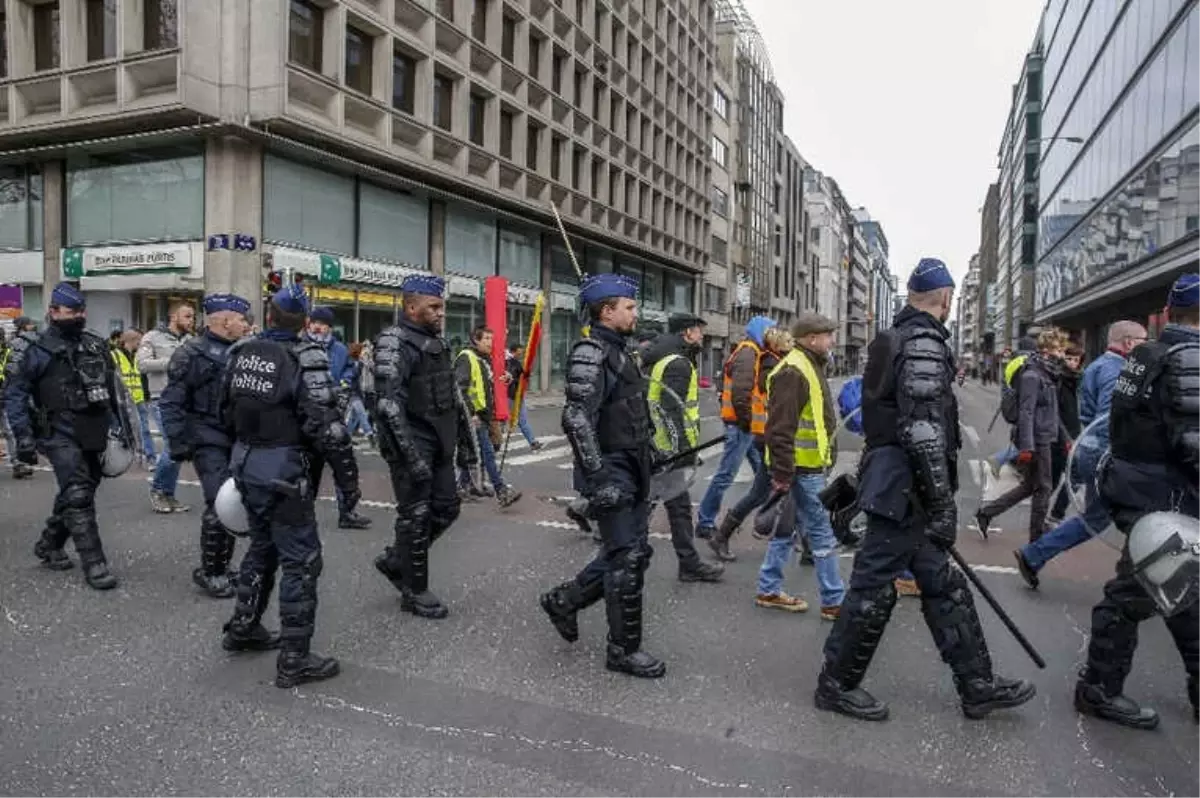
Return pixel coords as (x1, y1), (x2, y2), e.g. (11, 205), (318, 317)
(221, 284), (359, 688)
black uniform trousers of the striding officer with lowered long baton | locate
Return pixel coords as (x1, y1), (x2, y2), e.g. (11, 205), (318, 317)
(824, 514), (992, 689)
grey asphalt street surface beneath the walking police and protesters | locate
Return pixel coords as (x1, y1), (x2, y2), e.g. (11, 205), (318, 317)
(0, 383), (1200, 798)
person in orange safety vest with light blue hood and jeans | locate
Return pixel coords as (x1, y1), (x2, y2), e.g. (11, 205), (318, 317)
(696, 316), (775, 540)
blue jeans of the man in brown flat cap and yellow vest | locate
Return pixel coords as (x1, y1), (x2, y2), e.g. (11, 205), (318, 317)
(758, 474), (846, 607)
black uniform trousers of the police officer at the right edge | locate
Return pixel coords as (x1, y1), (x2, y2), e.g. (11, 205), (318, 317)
(1084, 525), (1200, 709)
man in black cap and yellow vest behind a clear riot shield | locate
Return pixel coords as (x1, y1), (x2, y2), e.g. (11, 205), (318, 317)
(642, 313), (725, 582)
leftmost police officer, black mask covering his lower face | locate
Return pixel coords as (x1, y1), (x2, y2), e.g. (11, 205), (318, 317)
(5, 283), (116, 590)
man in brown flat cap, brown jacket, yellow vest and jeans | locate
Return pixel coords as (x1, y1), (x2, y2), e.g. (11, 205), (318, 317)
(755, 313), (846, 620)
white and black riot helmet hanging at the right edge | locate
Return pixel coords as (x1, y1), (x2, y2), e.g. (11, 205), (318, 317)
(1129, 512), (1200, 616)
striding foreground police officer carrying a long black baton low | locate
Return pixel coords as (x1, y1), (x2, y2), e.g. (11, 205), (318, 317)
(815, 258), (1036, 720)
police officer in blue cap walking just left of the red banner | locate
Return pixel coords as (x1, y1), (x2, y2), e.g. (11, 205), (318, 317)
(374, 275), (478, 618)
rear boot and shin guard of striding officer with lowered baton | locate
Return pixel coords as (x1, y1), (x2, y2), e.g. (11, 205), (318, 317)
(812, 582), (896, 721)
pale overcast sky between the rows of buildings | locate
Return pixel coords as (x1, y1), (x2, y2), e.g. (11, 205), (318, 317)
(743, 0), (1044, 284)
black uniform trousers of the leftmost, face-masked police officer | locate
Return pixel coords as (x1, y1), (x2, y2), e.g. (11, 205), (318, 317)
(38, 432), (106, 568)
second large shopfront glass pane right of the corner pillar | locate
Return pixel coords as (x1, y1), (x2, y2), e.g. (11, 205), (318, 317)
(358, 182), (430, 269)
